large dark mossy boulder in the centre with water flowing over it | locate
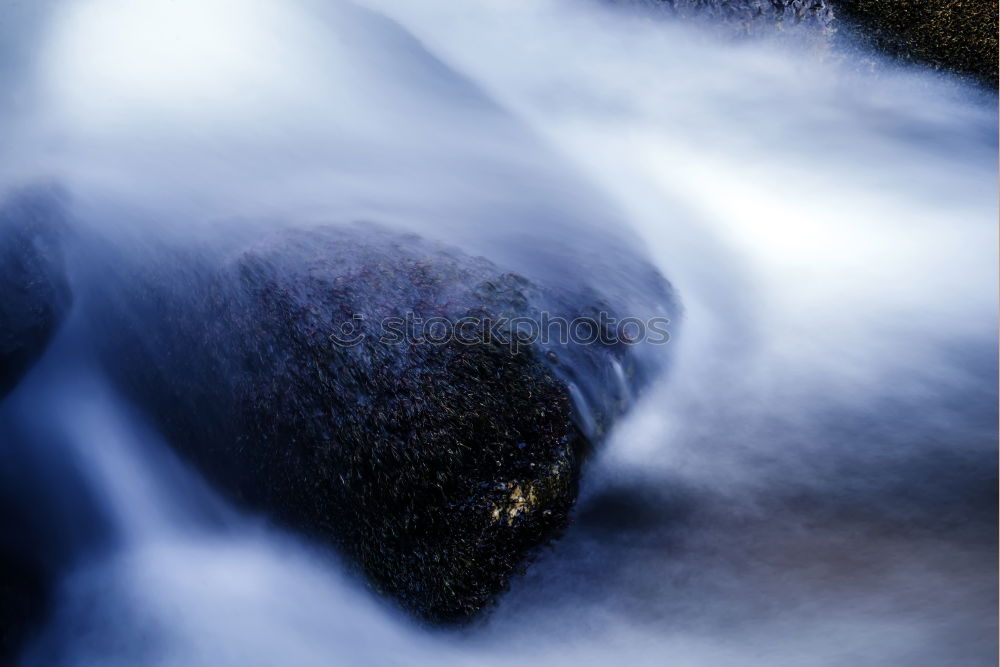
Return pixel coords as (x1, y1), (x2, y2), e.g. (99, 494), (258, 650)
(98, 226), (674, 622)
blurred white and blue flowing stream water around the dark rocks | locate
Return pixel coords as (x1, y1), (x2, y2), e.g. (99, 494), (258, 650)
(0, 0), (997, 666)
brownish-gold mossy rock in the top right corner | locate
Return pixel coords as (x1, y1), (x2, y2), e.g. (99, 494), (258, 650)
(830, 0), (998, 88)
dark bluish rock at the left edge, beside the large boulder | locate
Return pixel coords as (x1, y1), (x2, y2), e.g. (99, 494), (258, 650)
(0, 186), (71, 397)
